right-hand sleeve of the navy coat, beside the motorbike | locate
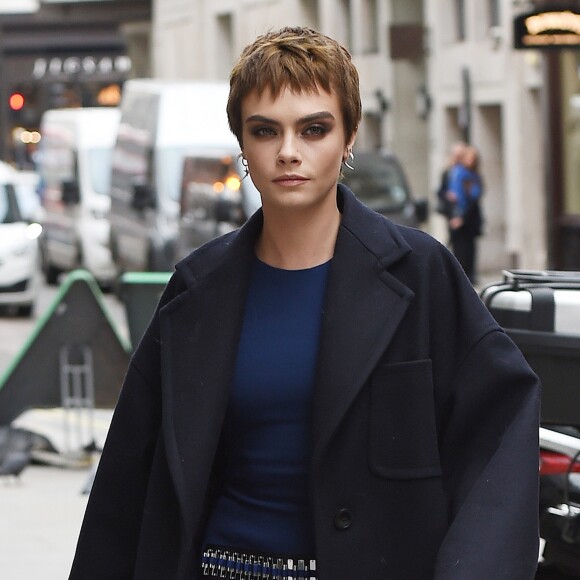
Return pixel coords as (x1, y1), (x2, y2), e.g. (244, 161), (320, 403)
(434, 326), (540, 580)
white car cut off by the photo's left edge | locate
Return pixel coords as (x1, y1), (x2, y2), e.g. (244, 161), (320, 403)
(0, 164), (42, 316)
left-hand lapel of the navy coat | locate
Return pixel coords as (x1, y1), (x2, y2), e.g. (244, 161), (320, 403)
(160, 214), (261, 530)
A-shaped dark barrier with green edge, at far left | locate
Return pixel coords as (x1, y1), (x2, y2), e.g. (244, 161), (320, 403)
(0, 270), (130, 425)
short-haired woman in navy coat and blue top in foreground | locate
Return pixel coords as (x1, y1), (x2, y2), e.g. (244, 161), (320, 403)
(70, 27), (539, 580)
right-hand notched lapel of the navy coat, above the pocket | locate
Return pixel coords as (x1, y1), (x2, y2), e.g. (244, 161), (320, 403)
(313, 189), (414, 462)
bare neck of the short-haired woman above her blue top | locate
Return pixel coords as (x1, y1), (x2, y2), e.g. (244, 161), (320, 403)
(256, 208), (340, 270)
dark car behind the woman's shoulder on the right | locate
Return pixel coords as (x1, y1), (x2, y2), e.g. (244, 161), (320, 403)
(341, 151), (428, 227)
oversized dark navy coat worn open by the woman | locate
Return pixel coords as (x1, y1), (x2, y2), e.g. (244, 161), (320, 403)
(70, 186), (539, 580)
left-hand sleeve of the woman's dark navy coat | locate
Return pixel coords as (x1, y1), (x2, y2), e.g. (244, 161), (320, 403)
(69, 276), (186, 580)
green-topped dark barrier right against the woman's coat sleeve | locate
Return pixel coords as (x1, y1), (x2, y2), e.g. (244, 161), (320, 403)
(119, 272), (171, 350)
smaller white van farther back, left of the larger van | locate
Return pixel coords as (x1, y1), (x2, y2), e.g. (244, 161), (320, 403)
(38, 107), (120, 286)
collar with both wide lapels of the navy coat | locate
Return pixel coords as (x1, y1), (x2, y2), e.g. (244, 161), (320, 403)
(160, 185), (413, 529)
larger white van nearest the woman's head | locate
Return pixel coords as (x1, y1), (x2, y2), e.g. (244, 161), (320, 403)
(109, 79), (240, 272)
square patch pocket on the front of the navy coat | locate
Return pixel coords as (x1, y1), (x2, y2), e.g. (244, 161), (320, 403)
(369, 360), (441, 479)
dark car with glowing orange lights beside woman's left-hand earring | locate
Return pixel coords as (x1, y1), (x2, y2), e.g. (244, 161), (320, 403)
(177, 152), (262, 257)
